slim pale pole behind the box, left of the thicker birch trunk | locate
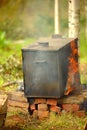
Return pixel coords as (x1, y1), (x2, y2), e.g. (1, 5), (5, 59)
(54, 0), (60, 34)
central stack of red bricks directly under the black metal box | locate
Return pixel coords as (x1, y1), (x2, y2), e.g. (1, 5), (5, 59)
(29, 98), (61, 119)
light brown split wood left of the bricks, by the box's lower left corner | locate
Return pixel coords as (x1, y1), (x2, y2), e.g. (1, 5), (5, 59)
(8, 91), (29, 113)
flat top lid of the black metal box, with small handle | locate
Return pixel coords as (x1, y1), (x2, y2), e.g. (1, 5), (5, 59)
(22, 37), (75, 51)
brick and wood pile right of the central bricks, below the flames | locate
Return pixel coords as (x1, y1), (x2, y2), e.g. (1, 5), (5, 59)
(59, 91), (87, 117)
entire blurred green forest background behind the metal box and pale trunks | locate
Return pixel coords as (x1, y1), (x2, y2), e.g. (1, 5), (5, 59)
(0, 0), (87, 84)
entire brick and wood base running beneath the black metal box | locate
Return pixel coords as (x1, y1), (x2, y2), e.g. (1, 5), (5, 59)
(8, 90), (87, 119)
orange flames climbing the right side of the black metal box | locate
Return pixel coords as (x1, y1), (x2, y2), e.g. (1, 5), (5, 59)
(64, 41), (78, 95)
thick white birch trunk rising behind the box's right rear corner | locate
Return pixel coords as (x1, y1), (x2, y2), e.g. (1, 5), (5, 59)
(69, 0), (80, 38)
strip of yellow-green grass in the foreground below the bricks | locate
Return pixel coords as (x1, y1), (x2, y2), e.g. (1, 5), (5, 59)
(15, 112), (87, 130)
